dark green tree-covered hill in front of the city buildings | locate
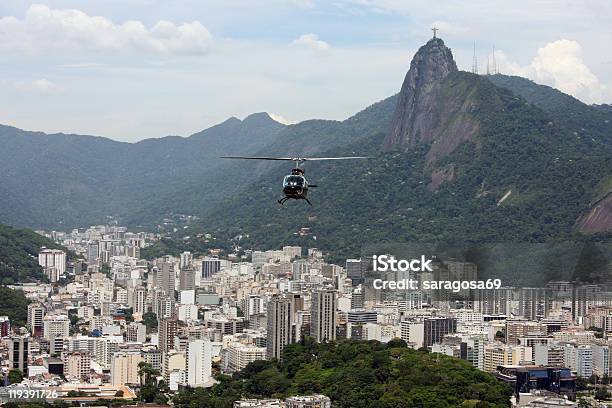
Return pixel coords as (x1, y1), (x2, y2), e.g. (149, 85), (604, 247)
(173, 340), (512, 408)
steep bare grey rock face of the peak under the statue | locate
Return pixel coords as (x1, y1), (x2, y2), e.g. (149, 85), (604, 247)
(383, 38), (478, 163)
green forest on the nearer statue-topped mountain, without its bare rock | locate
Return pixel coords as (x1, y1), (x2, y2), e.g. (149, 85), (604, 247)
(194, 72), (612, 284)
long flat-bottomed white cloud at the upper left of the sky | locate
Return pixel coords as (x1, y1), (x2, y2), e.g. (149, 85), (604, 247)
(0, 4), (212, 55)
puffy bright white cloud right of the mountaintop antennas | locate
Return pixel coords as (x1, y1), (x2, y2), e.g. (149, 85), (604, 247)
(495, 39), (607, 103)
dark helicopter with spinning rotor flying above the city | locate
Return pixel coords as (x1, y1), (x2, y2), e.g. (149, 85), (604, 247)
(221, 156), (371, 205)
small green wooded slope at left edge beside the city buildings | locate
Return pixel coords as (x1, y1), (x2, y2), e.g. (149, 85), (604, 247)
(0, 224), (65, 285)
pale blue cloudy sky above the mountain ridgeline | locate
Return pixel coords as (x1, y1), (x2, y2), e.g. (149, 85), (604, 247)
(0, 0), (612, 141)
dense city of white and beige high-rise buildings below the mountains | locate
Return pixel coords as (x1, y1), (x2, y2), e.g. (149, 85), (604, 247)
(0, 225), (612, 408)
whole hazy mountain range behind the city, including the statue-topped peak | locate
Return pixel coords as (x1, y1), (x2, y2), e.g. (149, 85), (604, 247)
(0, 39), (612, 253)
